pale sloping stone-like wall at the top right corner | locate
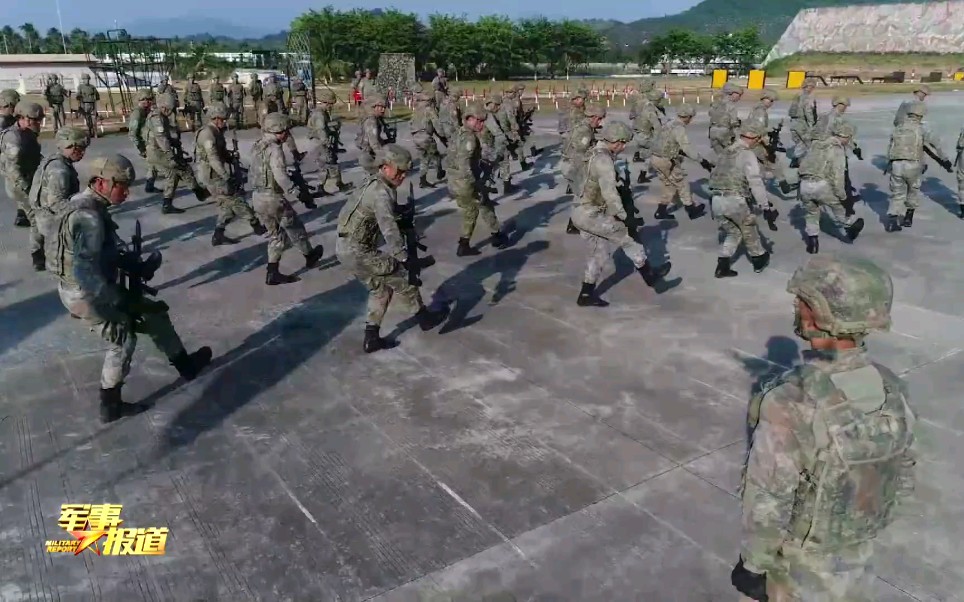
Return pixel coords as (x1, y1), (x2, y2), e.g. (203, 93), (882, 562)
(764, 0), (964, 64)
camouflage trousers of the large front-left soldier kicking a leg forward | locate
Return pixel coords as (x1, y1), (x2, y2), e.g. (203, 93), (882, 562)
(58, 285), (184, 389)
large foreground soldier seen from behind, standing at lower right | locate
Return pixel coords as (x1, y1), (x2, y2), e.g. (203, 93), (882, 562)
(731, 255), (916, 602)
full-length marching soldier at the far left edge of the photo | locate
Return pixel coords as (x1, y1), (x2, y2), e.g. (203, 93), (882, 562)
(0, 100), (44, 231)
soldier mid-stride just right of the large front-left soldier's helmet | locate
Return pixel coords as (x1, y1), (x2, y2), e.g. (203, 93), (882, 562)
(144, 96), (210, 215)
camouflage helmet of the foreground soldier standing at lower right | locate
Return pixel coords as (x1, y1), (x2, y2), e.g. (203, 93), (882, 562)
(787, 254), (894, 336)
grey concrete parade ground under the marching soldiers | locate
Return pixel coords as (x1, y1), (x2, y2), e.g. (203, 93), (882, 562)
(0, 92), (964, 602)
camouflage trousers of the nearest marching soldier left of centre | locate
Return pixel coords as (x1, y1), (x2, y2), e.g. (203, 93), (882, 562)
(335, 238), (423, 326)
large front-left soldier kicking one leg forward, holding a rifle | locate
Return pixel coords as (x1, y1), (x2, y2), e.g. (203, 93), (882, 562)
(47, 155), (212, 422)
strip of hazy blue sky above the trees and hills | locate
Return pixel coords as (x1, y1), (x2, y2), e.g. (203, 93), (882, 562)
(0, 0), (699, 35)
